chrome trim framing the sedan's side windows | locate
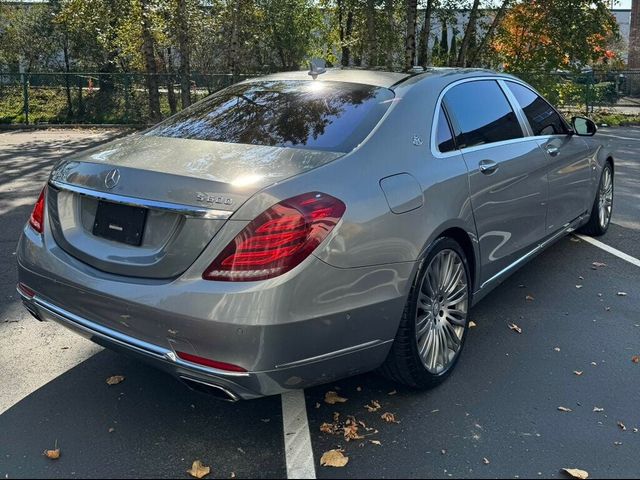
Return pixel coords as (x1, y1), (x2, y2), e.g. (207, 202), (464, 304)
(429, 75), (566, 159)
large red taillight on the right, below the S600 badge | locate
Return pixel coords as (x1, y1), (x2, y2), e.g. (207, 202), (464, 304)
(202, 192), (346, 282)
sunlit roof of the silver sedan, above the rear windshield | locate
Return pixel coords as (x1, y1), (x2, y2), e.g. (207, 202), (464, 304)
(245, 67), (498, 88)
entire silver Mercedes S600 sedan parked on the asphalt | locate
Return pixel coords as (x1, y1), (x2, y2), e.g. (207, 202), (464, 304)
(18, 69), (614, 400)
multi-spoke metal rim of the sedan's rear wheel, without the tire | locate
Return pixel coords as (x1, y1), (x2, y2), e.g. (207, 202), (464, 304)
(416, 249), (468, 375)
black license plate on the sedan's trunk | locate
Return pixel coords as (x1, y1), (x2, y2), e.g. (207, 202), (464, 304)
(93, 200), (147, 247)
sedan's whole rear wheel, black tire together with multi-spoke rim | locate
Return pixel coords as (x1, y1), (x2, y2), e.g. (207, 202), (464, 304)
(381, 237), (471, 389)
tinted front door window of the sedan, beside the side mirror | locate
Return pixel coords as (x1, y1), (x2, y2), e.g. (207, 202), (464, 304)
(506, 82), (569, 136)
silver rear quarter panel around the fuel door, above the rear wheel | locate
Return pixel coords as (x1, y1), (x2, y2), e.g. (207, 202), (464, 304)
(233, 74), (475, 286)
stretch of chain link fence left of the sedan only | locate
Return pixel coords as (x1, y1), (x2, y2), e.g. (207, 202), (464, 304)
(0, 73), (260, 125)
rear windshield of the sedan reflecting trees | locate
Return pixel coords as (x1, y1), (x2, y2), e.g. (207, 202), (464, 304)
(147, 80), (394, 152)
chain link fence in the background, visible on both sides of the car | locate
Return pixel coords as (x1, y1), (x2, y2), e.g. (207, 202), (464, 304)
(0, 71), (640, 125)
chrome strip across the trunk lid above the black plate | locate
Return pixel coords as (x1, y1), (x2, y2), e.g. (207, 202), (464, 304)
(49, 180), (233, 220)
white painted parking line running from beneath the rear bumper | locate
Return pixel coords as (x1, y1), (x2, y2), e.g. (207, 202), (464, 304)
(282, 390), (316, 478)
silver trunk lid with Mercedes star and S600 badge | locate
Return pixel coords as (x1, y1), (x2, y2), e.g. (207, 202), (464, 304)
(48, 135), (343, 278)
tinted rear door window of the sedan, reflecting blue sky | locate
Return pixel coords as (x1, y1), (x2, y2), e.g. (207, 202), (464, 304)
(444, 80), (524, 148)
